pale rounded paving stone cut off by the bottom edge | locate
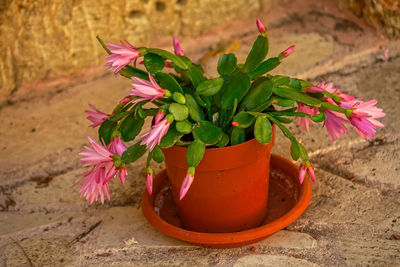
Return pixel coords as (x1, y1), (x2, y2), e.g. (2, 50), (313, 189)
(234, 255), (319, 267)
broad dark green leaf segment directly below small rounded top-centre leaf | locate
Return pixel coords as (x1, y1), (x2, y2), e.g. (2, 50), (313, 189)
(221, 71), (251, 109)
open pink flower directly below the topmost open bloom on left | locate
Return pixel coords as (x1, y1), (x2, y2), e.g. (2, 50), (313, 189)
(128, 73), (165, 103)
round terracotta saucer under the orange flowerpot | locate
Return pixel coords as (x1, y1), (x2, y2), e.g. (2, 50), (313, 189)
(142, 154), (311, 248)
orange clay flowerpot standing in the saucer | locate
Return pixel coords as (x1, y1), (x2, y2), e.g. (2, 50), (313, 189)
(163, 127), (275, 233)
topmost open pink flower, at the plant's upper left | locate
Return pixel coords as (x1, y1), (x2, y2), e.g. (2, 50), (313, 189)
(106, 40), (140, 74)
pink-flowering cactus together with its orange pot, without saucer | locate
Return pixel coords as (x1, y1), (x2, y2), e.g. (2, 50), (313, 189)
(78, 20), (385, 232)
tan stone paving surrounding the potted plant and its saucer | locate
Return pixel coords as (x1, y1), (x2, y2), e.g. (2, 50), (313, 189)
(0, 0), (400, 266)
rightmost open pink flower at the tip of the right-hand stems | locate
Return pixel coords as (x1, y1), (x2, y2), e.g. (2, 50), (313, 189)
(343, 99), (386, 139)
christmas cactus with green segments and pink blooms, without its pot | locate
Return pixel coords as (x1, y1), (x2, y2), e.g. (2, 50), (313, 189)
(78, 20), (385, 203)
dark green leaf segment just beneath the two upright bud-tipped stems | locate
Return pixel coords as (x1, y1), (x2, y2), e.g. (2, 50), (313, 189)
(242, 80), (274, 110)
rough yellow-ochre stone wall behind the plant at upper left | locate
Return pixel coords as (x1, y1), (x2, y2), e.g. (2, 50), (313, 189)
(0, 0), (262, 99)
